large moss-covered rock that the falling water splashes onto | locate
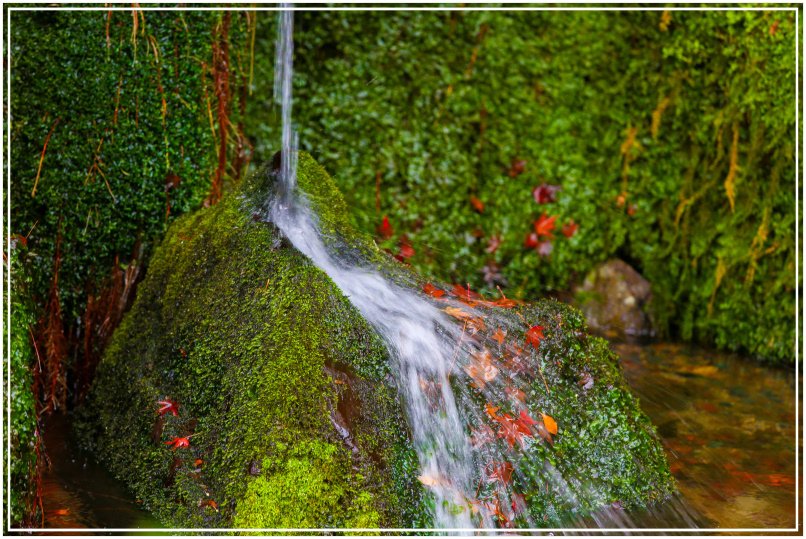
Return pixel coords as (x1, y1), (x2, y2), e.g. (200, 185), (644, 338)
(79, 154), (673, 528)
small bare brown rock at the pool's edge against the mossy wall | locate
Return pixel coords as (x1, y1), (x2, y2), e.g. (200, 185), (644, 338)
(574, 259), (655, 341)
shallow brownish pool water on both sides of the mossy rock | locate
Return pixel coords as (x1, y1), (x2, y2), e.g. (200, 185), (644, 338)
(34, 344), (802, 535)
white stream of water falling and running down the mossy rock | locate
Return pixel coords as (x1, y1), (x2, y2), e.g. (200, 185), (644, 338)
(269, 6), (473, 528)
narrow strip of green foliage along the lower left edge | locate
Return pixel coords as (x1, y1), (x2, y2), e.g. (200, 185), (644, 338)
(3, 245), (38, 526)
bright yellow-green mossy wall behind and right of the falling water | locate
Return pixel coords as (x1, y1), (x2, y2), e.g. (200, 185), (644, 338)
(250, 11), (796, 362)
